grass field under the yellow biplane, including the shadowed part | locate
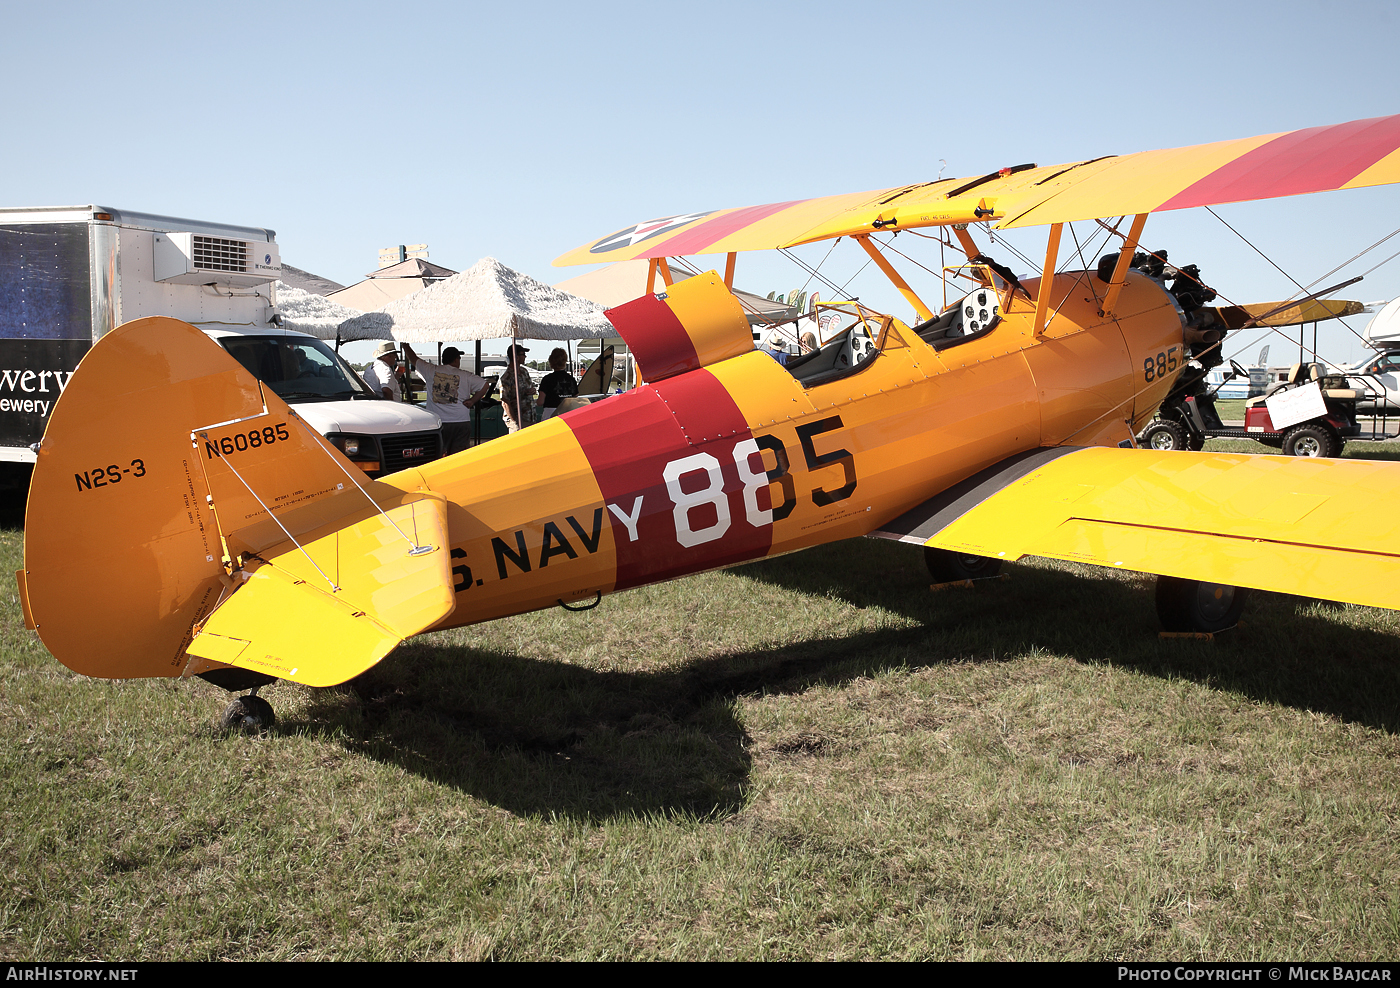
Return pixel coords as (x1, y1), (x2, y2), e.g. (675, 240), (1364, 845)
(0, 473), (1400, 960)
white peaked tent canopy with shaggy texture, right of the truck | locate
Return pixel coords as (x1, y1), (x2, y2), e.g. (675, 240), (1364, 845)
(333, 257), (617, 343)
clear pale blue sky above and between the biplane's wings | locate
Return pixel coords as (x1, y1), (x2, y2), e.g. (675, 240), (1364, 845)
(0, 0), (1400, 362)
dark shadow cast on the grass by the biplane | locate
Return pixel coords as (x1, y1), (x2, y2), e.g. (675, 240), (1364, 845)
(284, 539), (1400, 819)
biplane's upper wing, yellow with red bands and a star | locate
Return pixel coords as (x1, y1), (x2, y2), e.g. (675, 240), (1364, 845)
(554, 115), (1400, 266)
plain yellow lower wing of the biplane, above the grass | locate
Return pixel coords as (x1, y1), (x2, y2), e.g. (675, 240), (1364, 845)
(875, 446), (1400, 607)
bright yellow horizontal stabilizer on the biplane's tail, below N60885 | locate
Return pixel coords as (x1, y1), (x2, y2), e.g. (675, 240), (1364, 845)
(188, 497), (454, 686)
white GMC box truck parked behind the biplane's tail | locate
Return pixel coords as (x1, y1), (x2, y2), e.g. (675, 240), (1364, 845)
(0, 206), (441, 476)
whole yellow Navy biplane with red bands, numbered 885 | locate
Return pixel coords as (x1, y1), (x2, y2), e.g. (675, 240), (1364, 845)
(18, 116), (1400, 722)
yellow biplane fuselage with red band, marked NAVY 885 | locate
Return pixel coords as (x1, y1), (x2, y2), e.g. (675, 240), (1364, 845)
(382, 265), (1184, 627)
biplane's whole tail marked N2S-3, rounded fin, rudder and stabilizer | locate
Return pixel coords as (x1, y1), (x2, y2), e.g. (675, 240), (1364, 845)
(18, 316), (452, 683)
